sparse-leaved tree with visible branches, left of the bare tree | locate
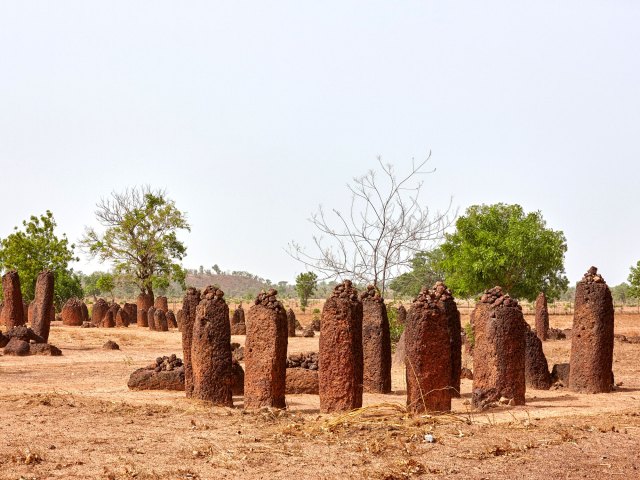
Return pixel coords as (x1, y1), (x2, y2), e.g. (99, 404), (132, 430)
(81, 186), (190, 295)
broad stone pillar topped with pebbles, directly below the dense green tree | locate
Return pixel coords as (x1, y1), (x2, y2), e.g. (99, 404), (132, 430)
(471, 287), (526, 409)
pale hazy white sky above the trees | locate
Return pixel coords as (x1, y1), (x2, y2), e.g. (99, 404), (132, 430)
(0, 0), (640, 284)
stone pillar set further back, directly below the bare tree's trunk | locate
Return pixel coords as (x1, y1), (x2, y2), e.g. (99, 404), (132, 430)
(360, 285), (391, 393)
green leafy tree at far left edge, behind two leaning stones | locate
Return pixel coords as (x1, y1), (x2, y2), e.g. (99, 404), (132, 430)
(0, 210), (83, 308)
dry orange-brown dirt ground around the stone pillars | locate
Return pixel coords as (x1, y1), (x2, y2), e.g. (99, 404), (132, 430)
(0, 315), (640, 479)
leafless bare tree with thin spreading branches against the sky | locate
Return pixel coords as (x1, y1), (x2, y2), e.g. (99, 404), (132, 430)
(288, 154), (455, 293)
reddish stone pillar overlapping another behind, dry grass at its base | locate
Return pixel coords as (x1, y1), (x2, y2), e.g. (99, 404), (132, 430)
(404, 287), (452, 413)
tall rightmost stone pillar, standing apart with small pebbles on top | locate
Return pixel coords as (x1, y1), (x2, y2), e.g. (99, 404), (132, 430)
(569, 267), (614, 393)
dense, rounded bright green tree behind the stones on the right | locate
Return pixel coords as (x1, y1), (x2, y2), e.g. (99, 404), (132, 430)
(439, 203), (568, 301)
